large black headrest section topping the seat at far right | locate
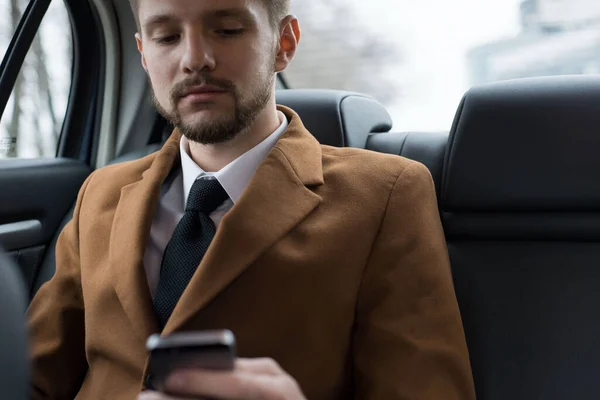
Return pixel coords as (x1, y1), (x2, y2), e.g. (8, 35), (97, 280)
(440, 76), (600, 211)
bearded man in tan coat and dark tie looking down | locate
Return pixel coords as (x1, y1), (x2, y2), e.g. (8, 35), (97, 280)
(29, 0), (474, 400)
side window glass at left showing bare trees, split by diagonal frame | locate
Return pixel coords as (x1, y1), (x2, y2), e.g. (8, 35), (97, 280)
(0, 0), (73, 159)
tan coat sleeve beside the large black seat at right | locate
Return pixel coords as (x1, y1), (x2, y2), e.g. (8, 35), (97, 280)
(353, 163), (475, 400)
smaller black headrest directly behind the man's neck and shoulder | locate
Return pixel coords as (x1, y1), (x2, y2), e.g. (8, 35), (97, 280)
(276, 89), (392, 148)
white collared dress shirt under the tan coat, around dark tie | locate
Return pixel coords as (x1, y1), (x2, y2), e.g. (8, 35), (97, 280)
(144, 111), (288, 297)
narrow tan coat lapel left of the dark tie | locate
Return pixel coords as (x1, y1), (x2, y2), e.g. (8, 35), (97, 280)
(109, 131), (180, 342)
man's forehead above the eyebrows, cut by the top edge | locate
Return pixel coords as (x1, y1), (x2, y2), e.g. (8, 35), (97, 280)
(138, 0), (266, 26)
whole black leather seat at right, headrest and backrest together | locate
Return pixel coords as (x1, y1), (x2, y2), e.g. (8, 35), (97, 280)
(440, 77), (600, 400)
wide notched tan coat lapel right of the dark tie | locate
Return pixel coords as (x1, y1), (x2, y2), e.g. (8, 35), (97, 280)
(163, 107), (323, 335)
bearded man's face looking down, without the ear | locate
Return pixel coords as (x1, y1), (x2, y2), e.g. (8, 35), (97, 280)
(137, 0), (279, 144)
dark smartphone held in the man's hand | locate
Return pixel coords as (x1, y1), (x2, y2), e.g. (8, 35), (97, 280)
(146, 330), (236, 392)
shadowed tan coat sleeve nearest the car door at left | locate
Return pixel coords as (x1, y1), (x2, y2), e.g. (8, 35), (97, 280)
(27, 176), (91, 400)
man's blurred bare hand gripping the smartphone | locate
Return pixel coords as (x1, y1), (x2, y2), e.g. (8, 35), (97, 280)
(138, 359), (306, 400)
